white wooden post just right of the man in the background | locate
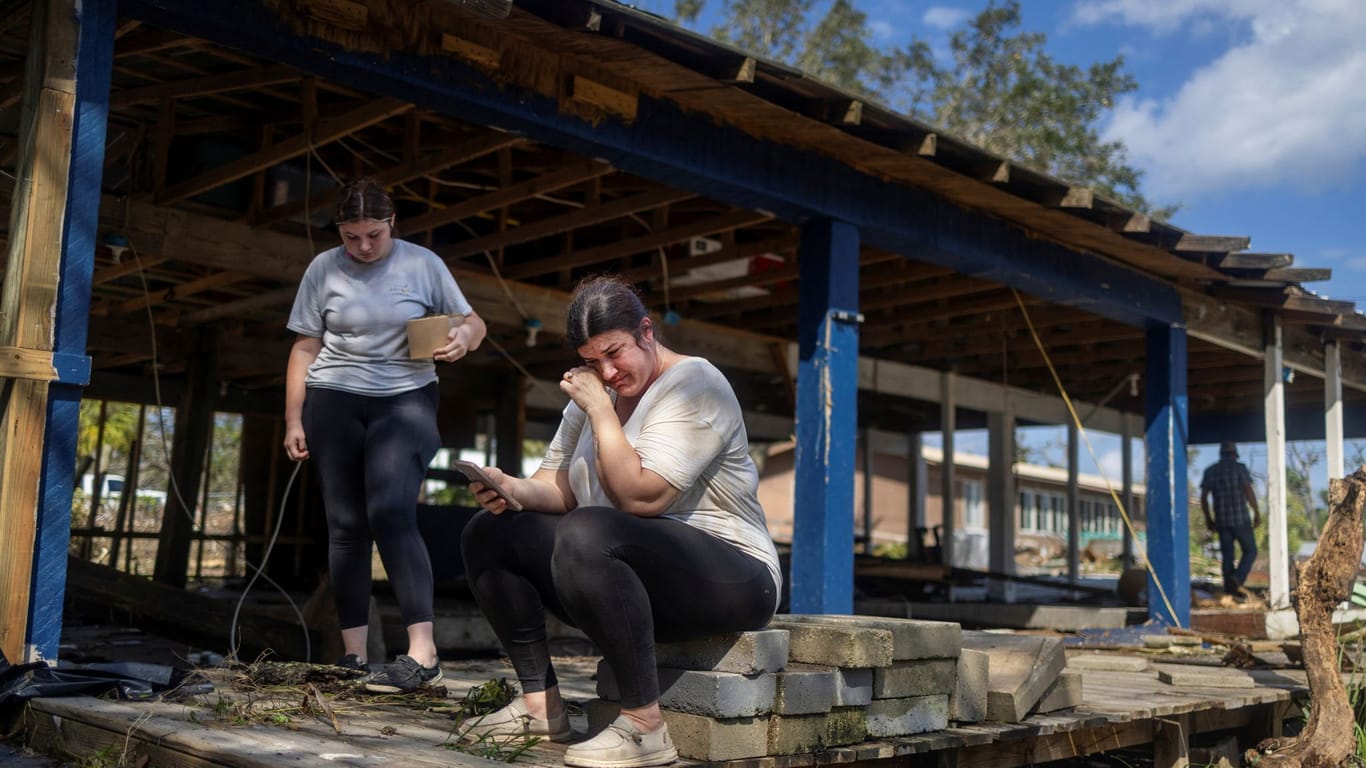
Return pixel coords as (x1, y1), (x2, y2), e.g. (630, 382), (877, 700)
(1262, 313), (1290, 608)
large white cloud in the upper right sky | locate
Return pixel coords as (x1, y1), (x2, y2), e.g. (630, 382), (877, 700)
(1074, 0), (1366, 201)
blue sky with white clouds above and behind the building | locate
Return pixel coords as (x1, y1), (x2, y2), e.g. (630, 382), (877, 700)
(635, 0), (1366, 484)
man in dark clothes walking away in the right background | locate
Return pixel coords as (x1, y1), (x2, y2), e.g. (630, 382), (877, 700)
(1199, 441), (1261, 599)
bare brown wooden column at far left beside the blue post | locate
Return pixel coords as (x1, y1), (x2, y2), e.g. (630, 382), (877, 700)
(0, 0), (87, 663)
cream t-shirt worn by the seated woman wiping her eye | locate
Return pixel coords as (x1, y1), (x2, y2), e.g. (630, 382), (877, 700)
(541, 357), (783, 609)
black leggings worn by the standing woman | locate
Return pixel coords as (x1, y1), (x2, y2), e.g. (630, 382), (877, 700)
(303, 381), (441, 630)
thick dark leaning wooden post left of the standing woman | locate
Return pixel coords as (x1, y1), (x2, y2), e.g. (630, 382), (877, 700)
(153, 325), (221, 586)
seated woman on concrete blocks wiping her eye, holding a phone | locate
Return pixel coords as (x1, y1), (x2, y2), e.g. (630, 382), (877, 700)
(460, 271), (781, 768)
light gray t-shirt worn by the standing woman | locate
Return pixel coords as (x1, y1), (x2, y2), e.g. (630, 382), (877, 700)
(288, 239), (473, 395)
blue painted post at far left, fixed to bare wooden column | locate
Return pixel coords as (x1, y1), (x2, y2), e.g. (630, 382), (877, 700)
(26, 0), (119, 659)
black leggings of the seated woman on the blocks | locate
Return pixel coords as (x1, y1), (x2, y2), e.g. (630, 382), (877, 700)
(460, 507), (777, 707)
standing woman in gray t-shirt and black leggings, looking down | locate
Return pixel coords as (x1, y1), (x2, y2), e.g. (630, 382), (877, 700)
(284, 178), (485, 693)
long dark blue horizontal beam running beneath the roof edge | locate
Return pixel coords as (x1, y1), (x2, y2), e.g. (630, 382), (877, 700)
(123, 0), (1182, 327)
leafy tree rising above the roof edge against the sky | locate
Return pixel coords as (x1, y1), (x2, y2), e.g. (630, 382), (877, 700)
(688, 0), (1176, 219)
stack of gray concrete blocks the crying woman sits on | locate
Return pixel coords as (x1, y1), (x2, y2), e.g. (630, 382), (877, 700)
(587, 615), (986, 761)
